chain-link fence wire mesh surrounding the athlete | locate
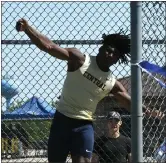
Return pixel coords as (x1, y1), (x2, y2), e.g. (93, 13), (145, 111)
(1, 2), (166, 162)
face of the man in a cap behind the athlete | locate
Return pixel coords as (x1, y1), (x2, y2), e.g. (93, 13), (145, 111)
(108, 118), (122, 132)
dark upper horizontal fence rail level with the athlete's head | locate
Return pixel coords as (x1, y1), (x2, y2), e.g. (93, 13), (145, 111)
(1, 39), (166, 45)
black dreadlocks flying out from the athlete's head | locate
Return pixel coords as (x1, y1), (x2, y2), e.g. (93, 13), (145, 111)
(102, 32), (130, 63)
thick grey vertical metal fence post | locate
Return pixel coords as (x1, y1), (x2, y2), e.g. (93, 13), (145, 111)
(131, 2), (143, 162)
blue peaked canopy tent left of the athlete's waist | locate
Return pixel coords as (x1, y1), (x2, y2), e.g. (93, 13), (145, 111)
(1, 96), (56, 120)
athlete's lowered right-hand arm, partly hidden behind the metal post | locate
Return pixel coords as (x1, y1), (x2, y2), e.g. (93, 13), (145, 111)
(110, 81), (165, 118)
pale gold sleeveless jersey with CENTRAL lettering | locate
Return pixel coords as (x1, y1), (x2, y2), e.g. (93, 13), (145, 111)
(57, 55), (116, 120)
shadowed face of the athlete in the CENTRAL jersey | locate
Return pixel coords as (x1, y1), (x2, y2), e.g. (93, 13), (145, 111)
(100, 45), (120, 66)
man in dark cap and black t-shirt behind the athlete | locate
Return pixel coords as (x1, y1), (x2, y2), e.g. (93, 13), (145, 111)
(91, 111), (131, 163)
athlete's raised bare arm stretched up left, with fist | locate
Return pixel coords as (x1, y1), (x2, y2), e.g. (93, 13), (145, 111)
(16, 18), (84, 61)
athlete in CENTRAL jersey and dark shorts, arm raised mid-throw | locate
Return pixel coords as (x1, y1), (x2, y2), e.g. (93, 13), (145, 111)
(16, 19), (163, 163)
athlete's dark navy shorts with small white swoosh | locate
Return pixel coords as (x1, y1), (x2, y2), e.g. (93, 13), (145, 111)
(48, 111), (94, 162)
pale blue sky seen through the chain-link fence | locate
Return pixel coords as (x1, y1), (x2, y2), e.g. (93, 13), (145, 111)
(1, 2), (166, 110)
